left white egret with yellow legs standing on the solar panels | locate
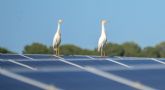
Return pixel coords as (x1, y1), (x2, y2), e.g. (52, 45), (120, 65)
(53, 19), (63, 56)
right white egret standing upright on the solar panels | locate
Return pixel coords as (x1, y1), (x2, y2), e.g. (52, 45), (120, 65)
(98, 20), (107, 56)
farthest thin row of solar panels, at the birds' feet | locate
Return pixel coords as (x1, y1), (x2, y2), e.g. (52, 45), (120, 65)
(0, 54), (165, 60)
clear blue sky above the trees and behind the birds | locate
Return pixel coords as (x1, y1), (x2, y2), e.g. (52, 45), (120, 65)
(0, 0), (165, 53)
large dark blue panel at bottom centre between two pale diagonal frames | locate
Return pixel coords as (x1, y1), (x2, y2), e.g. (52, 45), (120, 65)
(21, 72), (132, 90)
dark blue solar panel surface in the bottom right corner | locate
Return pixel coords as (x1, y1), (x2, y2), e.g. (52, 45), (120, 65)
(111, 69), (165, 90)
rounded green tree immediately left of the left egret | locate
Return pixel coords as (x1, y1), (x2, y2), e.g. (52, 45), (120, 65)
(23, 43), (50, 54)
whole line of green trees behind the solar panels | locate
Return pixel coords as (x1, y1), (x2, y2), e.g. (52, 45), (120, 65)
(0, 42), (165, 57)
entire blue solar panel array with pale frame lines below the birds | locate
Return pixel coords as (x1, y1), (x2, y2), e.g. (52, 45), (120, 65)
(0, 54), (165, 90)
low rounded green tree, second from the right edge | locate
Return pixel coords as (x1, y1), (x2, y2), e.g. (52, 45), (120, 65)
(141, 47), (160, 57)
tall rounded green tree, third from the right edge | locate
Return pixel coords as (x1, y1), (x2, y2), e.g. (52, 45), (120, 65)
(122, 42), (141, 56)
